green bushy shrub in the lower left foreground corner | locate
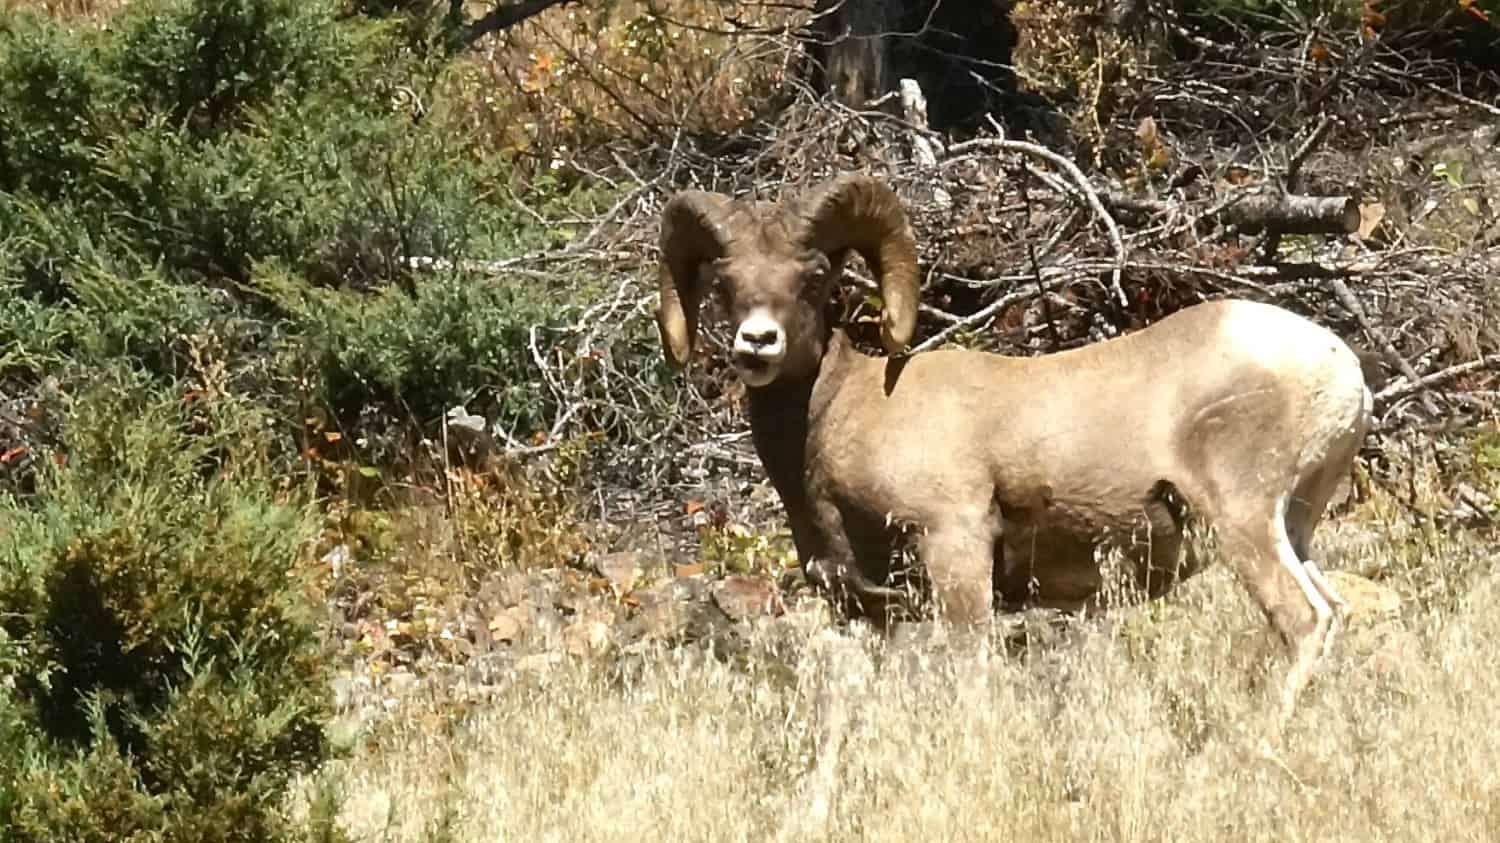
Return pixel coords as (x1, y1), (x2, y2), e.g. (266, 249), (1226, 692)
(0, 366), (327, 840)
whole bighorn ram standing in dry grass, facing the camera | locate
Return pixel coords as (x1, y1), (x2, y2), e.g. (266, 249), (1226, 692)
(657, 174), (1371, 707)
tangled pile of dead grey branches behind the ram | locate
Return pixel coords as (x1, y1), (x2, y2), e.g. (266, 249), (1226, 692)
(435, 9), (1500, 528)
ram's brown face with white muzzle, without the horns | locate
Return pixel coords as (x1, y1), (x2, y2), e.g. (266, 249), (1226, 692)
(705, 245), (833, 387)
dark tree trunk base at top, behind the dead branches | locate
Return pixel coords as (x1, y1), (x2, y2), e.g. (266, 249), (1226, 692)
(810, 0), (1016, 129)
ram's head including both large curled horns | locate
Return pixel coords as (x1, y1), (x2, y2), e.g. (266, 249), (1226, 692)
(657, 174), (918, 387)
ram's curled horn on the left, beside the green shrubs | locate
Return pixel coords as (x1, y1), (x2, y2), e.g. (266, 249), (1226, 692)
(657, 191), (734, 368)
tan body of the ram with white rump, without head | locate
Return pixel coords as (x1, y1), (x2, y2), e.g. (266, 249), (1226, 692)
(786, 302), (1370, 638)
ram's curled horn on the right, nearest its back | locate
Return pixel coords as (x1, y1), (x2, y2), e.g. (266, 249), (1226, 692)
(801, 173), (918, 354)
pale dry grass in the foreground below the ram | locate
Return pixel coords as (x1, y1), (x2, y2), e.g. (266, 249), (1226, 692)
(289, 474), (1500, 842)
